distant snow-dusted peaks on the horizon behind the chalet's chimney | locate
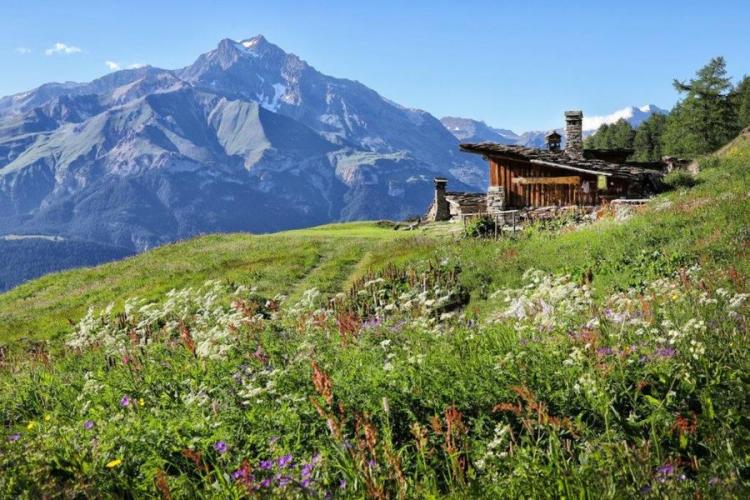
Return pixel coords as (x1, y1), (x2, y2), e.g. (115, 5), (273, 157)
(440, 104), (667, 147)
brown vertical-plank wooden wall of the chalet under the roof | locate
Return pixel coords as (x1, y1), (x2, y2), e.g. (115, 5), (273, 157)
(489, 157), (628, 209)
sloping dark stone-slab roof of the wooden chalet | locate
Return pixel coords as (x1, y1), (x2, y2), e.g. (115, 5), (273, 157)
(460, 142), (662, 181)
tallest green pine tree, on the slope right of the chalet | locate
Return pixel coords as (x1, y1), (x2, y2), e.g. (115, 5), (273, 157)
(663, 57), (738, 157)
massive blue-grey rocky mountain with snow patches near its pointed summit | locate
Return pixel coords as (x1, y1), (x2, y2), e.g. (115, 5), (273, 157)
(0, 36), (668, 290)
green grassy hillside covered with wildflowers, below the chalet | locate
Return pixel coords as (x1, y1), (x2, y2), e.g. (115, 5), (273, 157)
(0, 132), (750, 498)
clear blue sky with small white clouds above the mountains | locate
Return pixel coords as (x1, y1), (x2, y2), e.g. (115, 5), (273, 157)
(0, 0), (750, 132)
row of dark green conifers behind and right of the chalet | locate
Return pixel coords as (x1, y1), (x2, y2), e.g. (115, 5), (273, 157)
(585, 57), (750, 161)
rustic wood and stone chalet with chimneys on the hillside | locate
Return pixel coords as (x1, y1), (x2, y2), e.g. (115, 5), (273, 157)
(426, 111), (671, 221)
